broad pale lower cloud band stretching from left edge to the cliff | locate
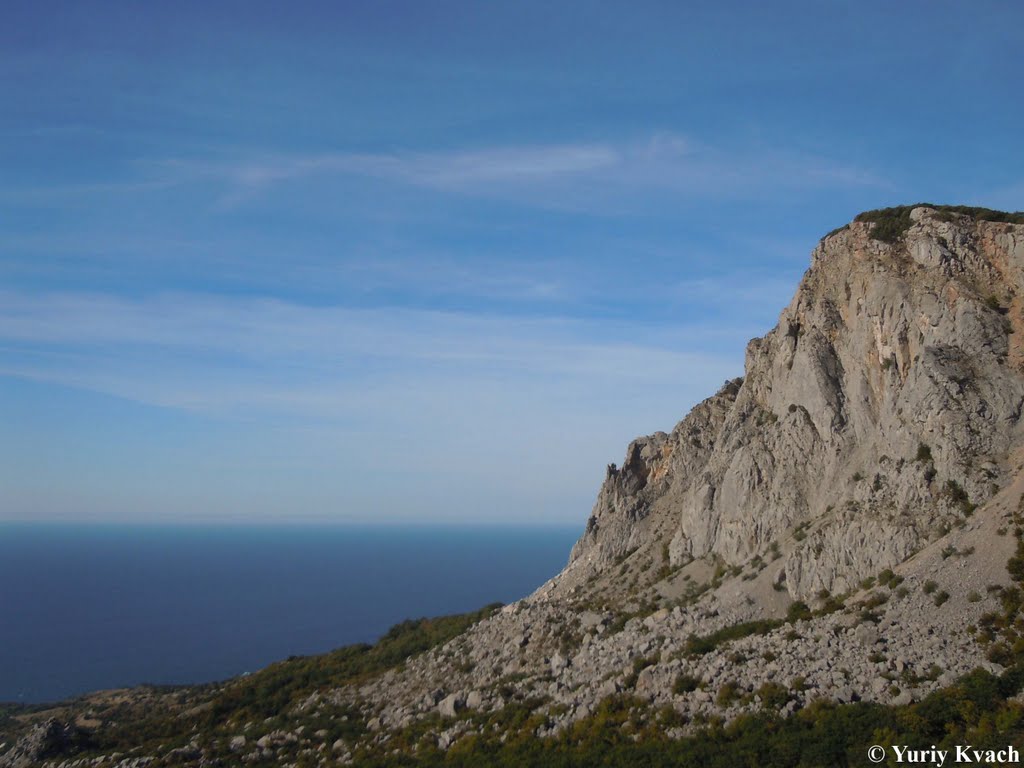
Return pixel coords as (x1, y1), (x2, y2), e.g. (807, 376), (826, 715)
(0, 293), (738, 419)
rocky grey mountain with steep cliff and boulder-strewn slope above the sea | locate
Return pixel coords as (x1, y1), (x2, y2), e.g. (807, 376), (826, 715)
(6, 206), (1024, 767)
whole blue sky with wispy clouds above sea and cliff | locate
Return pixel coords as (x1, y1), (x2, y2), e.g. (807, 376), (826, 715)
(0, 0), (1024, 526)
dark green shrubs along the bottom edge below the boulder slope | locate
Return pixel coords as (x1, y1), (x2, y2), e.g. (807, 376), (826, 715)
(350, 672), (1024, 768)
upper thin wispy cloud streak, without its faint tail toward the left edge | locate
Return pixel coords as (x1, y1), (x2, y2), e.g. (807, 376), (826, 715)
(149, 133), (888, 206)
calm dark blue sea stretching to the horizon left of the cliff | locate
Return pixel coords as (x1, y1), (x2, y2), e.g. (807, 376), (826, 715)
(0, 524), (581, 702)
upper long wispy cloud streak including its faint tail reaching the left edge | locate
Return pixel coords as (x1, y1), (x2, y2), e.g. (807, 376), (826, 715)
(0, 133), (892, 213)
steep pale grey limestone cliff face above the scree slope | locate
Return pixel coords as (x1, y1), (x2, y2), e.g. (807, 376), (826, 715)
(570, 207), (1024, 597)
